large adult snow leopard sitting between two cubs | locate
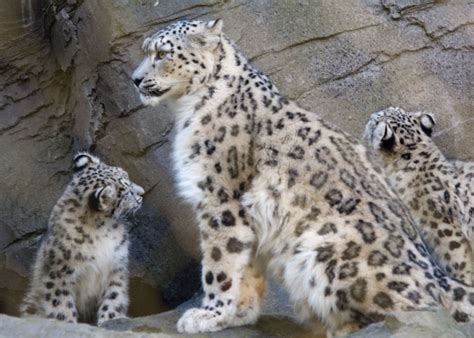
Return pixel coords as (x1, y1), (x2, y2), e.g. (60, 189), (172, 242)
(133, 21), (474, 333)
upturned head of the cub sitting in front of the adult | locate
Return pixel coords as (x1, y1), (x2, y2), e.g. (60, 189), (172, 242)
(69, 152), (144, 218)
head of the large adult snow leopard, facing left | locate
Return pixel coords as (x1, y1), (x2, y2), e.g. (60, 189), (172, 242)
(132, 20), (222, 105)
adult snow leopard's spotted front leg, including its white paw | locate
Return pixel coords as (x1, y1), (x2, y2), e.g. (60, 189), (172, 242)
(177, 200), (264, 333)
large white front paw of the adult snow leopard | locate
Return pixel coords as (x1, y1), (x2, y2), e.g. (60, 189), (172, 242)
(176, 308), (235, 333)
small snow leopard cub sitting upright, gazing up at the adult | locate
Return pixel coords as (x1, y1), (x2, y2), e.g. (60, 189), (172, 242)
(21, 153), (143, 325)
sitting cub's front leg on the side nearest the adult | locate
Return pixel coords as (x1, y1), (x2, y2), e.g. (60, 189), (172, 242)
(97, 263), (128, 326)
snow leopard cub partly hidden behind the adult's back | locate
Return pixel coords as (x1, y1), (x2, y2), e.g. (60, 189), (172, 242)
(366, 107), (474, 285)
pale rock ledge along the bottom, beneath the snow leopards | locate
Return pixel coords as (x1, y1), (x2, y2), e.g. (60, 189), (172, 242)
(0, 309), (474, 338)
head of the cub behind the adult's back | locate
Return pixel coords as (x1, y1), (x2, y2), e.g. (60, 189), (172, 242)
(364, 107), (435, 166)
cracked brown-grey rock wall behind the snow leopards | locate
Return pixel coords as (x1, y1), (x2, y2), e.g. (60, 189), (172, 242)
(0, 0), (474, 322)
